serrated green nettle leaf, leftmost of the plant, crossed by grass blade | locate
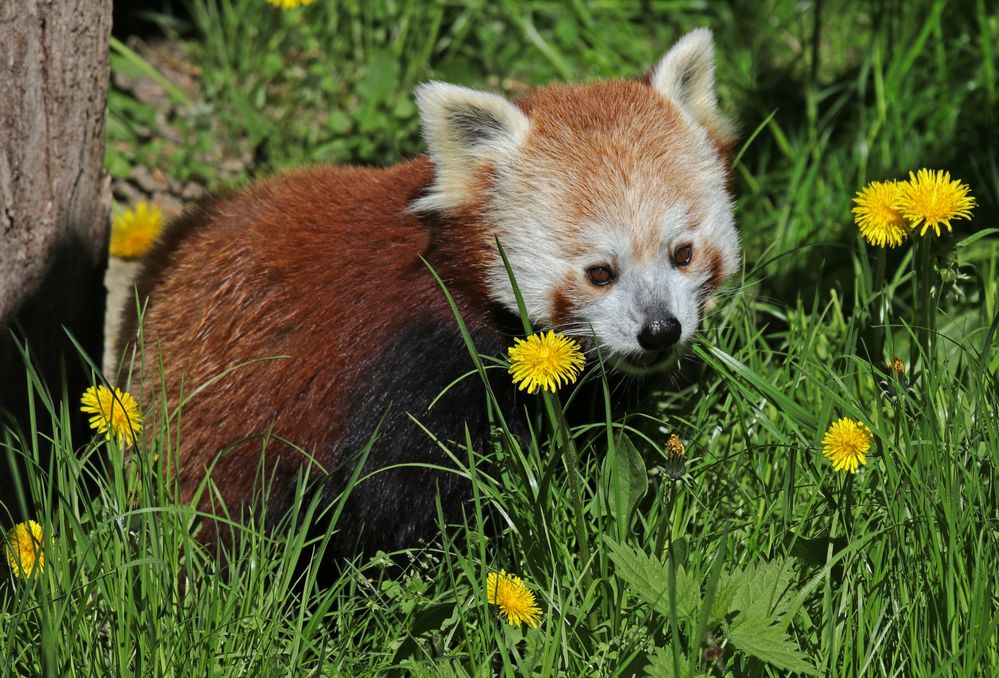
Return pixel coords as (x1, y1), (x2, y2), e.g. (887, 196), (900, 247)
(605, 537), (701, 618)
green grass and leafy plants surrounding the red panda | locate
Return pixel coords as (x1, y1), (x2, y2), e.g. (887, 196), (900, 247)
(0, 0), (999, 676)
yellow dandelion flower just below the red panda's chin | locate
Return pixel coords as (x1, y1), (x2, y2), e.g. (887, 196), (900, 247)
(509, 330), (586, 393)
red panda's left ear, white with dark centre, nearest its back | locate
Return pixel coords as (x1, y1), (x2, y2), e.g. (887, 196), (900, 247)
(413, 81), (530, 210)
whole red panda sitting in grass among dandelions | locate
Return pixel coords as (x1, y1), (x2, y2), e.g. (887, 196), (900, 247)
(119, 29), (740, 556)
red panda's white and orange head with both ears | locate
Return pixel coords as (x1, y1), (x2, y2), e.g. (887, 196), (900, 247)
(414, 29), (739, 362)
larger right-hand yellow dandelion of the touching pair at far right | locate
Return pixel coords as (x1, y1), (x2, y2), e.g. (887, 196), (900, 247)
(899, 169), (977, 237)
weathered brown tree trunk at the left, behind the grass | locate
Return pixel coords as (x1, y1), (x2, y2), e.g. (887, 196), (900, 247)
(0, 0), (111, 526)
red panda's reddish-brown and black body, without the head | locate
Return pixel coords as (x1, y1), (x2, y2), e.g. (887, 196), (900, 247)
(127, 159), (524, 554)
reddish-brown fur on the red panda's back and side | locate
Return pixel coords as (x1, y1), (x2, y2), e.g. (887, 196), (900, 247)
(124, 158), (500, 536)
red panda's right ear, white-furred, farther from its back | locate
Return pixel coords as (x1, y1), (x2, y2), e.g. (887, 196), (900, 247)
(648, 28), (735, 146)
